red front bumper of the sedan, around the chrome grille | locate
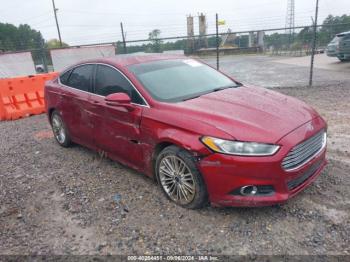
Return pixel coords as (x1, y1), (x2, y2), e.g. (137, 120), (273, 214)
(199, 118), (327, 206)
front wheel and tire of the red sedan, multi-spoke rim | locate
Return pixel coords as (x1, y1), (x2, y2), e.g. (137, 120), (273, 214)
(156, 146), (208, 209)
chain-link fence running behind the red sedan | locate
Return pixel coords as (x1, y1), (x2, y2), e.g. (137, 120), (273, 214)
(0, 24), (350, 87)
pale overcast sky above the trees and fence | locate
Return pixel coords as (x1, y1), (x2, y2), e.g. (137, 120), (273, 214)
(0, 0), (350, 45)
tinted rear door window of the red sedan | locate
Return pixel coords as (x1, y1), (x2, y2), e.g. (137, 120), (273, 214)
(67, 65), (94, 92)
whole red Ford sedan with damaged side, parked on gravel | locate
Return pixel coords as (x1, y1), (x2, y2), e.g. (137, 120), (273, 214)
(45, 55), (327, 208)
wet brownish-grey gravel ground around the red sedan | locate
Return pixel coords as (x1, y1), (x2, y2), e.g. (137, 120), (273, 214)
(0, 57), (350, 255)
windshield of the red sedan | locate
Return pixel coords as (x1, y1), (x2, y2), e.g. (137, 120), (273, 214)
(129, 59), (239, 102)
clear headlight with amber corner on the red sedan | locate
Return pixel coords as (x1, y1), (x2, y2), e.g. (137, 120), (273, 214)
(201, 136), (280, 156)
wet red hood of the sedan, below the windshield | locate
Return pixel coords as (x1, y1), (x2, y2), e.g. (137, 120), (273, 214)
(168, 86), (318, 143)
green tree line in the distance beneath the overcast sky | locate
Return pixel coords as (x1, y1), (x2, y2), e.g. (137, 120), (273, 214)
(0, 15), (350, 53)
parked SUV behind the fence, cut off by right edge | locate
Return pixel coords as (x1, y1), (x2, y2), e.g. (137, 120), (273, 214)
(327, 31), (350, 61)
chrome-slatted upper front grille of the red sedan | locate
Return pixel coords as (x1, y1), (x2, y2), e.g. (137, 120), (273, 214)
(282, 130), (327, 171)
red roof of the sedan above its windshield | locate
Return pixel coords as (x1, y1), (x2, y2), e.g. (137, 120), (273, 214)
(79, 54), (185, 67)
